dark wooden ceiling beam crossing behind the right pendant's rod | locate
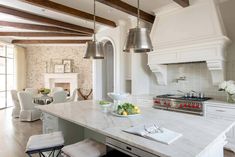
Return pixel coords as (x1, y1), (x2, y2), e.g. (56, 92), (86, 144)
(96, 0), (155, 23)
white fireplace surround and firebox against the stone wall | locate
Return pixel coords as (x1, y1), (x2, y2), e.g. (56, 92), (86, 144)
(44, 73), (78, 93)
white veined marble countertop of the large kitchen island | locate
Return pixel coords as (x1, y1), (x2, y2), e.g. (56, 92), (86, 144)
(37, 100), (234, 157)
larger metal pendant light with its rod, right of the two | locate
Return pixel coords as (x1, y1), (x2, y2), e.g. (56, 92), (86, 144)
(123, 0), (153, 53)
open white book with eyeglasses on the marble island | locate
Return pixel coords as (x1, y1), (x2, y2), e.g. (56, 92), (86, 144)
(123, 124), (182, 145)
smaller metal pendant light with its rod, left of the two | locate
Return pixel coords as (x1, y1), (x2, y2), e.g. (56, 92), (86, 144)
(83, 0), (104, 59)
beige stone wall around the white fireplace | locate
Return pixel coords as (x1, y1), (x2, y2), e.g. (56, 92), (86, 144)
(26, 45), (92, 95)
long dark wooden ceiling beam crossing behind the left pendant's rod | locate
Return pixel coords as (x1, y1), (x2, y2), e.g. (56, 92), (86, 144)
(21, 0), (116, 27)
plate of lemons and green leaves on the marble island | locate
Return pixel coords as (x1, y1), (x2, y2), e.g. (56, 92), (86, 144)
(113, 103), (140, 117)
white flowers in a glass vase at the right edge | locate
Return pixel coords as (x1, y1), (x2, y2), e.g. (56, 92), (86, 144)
(219, 80), (235, 103)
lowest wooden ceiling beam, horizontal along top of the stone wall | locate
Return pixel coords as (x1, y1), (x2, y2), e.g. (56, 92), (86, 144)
(11, 40), (90, 44)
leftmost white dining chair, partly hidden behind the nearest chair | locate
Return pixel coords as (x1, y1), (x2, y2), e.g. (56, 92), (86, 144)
(11, 90), (20, 118)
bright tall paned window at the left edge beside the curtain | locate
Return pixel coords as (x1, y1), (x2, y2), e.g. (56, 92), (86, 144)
(0, 45), (15, 109)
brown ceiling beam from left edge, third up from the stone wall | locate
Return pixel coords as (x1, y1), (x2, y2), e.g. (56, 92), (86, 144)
(0, 21), (88, 34)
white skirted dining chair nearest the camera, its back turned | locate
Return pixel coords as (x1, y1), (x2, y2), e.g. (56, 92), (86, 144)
(18, 91), (41, 121)
